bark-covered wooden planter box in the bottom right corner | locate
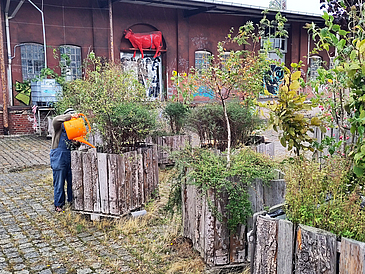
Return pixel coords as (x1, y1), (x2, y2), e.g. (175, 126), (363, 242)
(251, 216), (365, 274)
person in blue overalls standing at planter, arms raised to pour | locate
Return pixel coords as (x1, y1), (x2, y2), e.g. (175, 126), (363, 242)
(50, 108), (80, 212)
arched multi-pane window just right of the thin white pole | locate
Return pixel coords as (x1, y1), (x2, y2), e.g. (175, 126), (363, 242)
(60, 45), (82, 81)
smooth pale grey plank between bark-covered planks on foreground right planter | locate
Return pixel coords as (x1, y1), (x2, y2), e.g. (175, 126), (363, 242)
(276, 220), (295, 274)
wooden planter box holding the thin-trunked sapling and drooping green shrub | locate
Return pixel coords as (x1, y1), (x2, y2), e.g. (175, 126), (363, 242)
(182, 180), (285, 266)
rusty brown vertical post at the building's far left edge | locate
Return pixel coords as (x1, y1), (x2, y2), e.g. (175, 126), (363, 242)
(0, 2), (9, 135)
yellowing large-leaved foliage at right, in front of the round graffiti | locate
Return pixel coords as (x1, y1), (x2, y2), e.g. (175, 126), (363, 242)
(260, 63), (325, 155)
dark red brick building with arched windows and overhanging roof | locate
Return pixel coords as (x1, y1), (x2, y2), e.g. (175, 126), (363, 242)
(0, 0), (329, 135)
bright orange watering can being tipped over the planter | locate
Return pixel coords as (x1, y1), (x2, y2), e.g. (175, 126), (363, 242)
(63, 113), (95, 148)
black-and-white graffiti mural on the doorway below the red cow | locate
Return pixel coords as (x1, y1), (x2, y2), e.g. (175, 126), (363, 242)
(120, 52), (162, 99)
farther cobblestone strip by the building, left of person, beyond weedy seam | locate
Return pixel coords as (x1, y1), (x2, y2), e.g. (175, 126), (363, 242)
(0, 135), (51, 173)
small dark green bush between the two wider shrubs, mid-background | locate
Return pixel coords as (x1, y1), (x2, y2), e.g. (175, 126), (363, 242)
(162, 101), (189, 134)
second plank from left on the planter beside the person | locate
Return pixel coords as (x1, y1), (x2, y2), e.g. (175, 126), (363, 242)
(82, 153), (94, 211)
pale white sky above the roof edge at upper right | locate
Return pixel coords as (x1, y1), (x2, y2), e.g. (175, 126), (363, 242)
(224, 0), (323, 14)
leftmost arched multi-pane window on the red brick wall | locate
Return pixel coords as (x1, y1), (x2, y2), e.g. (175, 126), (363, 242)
(20, 43), (44, 81)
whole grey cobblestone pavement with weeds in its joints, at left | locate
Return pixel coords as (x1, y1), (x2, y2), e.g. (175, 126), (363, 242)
(0, 136), (133, 274)
